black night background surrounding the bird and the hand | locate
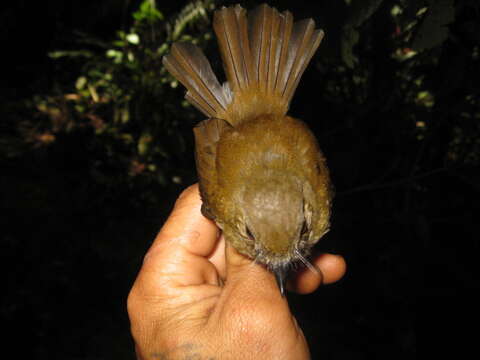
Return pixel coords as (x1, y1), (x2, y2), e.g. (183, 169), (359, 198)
(0, 0), (480, 359)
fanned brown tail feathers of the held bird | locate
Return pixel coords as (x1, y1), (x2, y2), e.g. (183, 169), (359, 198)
(163, 4), (324, 125)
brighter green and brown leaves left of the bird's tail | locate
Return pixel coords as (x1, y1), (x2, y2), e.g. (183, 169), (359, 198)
(13, 0), (213, 191)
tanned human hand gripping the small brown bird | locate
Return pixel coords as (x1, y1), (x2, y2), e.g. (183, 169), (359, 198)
(127, 185), (346, 360)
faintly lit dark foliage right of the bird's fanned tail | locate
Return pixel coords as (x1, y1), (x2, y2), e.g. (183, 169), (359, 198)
(328, 0), (480, 179)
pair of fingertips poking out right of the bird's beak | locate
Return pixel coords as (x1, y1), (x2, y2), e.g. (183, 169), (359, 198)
(287, 254), (347, 294)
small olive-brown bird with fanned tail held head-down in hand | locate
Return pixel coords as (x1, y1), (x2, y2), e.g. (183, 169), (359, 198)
(163, 4), (332, 295)
